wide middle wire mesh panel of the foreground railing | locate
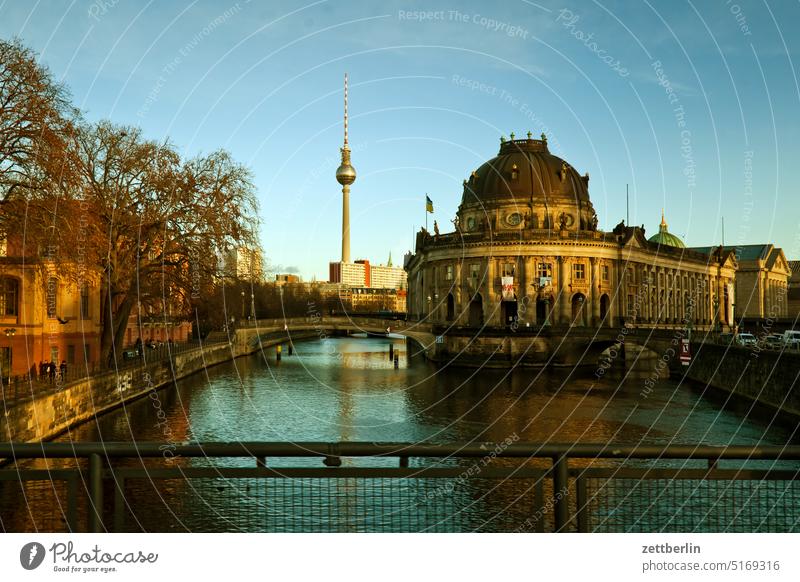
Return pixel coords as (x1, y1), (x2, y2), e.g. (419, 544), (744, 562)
(112, 478), (548, 532)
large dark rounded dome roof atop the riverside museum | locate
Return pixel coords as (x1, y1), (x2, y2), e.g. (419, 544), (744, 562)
(462, 133), (591, 206)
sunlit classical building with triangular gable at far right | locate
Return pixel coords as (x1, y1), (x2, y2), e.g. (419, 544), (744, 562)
(692, 244), (791, 320)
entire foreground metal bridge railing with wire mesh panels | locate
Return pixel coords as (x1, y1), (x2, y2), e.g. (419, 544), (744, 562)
(0, 441), (800, 532)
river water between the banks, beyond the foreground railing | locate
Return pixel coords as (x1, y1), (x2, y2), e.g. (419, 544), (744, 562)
(54, 338), (793, 445)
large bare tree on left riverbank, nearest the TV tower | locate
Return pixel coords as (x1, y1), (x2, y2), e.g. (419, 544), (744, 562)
(73, 123), (257, 361)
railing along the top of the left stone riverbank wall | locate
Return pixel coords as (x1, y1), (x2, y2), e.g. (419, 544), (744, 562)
(0, 339), (227, 407)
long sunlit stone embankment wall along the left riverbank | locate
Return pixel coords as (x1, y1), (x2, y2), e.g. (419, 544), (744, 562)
(0, 328), (315, 442)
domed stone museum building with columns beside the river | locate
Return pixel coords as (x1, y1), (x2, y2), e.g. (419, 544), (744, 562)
(405, 133), (737, 331)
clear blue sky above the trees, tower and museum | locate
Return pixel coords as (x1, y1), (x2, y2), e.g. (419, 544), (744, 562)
(0, 0), (800, 280)
